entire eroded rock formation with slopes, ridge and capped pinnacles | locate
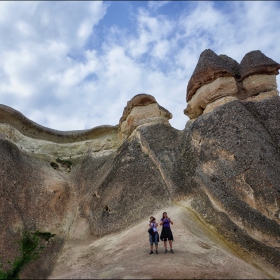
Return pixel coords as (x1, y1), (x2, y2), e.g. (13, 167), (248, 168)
(0, 50), (280, 279)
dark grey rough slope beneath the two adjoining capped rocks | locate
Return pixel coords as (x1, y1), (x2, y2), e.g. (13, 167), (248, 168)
(186, 99), (280, 274)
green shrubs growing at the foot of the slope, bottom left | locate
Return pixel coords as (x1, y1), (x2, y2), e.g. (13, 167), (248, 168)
(0, 230), (55, 279)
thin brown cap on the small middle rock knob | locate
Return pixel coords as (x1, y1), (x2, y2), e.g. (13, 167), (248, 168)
(119, 93), (157, 125)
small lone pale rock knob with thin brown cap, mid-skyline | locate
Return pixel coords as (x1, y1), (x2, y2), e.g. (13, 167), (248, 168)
(119, 93), (172, 142)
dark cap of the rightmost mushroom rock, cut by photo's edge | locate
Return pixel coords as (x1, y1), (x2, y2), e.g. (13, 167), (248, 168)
(240, 50), (280, 81)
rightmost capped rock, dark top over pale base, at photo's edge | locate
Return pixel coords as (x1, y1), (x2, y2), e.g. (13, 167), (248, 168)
(238, 51), (280, 100)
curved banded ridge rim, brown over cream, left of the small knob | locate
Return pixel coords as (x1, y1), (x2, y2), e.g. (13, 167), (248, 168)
(0, 104), (119, 158)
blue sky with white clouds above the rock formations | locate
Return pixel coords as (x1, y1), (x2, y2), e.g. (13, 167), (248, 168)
(0, 1), (280, 131)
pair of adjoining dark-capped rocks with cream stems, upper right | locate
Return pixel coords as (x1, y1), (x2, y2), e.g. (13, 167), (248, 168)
(184, 50), (280, 119)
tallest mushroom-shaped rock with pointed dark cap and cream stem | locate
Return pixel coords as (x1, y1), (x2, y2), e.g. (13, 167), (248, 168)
(184, 50), (240, 119)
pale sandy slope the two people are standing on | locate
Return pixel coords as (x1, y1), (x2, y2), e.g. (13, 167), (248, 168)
(49, 205), (271, 279)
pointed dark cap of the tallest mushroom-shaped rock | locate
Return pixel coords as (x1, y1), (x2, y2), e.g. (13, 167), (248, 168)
(187, 49), (235, 101)
